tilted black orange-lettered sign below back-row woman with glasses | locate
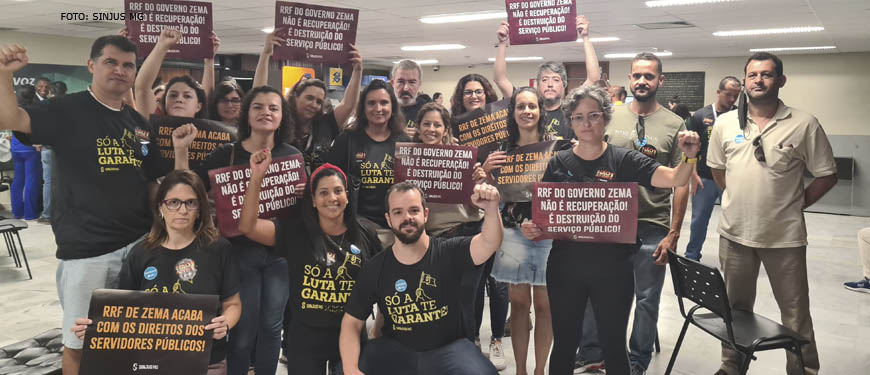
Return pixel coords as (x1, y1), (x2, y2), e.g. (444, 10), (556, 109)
(452, 99), (510, 153)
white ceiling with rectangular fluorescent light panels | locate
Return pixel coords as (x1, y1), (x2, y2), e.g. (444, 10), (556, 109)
(0, 0), (870, 65)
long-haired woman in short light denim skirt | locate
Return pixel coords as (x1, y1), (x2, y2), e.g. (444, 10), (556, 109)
(483, 87), (553, 375)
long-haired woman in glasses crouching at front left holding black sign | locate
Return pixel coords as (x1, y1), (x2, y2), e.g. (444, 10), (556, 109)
(72, 171), (242, 375)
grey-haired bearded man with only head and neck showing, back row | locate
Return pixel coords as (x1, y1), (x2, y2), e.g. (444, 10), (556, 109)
(390, 60), (432, 139)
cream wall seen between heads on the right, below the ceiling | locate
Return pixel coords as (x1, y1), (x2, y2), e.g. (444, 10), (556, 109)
(423, 53), (870, 135)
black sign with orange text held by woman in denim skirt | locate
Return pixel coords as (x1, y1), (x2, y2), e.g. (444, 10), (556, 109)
(492, 141), (565, 202)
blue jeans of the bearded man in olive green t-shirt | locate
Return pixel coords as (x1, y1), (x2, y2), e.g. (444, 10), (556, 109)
(580, 222), (668, 369)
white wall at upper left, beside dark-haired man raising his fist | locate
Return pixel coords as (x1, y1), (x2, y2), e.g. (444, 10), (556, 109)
(0, 30), (93, 66)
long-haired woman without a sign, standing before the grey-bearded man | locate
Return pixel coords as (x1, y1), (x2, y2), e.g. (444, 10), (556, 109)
(325, 79), (411, 247)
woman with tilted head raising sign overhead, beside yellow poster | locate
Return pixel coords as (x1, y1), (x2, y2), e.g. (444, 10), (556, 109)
(254, 29), (362, 171)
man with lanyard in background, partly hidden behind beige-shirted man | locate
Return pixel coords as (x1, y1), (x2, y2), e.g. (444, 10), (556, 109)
(686, 76), (740, 260)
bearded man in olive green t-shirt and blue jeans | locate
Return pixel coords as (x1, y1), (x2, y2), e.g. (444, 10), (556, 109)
(578, 53), (689, 375)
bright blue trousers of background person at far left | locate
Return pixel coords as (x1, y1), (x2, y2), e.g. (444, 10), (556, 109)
(9, 151), (42, 220)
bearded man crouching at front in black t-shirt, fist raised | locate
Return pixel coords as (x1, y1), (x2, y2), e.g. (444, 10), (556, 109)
(339, 182), (503, 375)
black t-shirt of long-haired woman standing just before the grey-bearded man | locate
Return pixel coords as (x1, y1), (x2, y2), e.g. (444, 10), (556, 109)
(325, 129), (411, 228)
